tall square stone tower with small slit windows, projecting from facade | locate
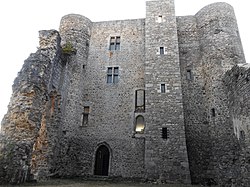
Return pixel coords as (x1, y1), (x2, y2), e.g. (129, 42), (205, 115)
(145, 0), (190, 183)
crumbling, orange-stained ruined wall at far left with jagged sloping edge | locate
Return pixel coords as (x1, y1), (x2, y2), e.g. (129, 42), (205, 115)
(0, 30), (60, 183)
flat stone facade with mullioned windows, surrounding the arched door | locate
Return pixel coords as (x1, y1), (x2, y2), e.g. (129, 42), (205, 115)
(56, 19), (144, 178)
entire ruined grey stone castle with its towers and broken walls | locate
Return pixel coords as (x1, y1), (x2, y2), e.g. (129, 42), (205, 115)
(0, 0), (250, 186)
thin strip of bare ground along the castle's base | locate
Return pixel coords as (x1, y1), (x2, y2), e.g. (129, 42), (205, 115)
(6, 179), (213, 187)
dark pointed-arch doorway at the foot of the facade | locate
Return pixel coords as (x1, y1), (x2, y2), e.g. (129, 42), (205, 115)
(94, 145), (110, 176)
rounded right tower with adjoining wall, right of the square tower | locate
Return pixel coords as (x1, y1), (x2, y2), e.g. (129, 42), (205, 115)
(178, 3), (245, 185)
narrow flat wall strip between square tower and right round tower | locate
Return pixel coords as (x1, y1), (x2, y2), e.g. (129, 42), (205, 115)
(177, 16), (211, 183)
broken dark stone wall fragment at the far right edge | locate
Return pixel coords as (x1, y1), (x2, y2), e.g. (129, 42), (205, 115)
(223, 64), (250, 186)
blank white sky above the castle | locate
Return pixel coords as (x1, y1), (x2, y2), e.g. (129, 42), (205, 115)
(0, 0), (247, 122)
